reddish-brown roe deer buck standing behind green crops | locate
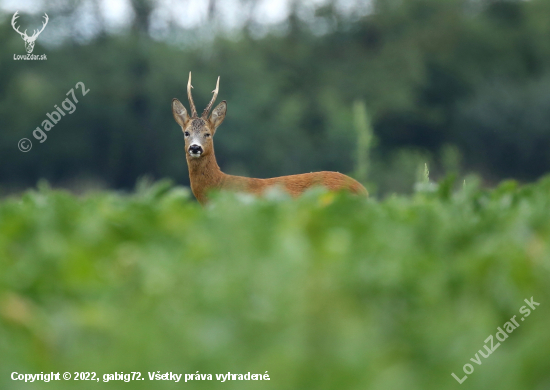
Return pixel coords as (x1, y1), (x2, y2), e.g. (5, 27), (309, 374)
(172, 72), (368, 204)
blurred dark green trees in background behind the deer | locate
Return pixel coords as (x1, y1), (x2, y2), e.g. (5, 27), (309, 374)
(0, 0), (550, 194)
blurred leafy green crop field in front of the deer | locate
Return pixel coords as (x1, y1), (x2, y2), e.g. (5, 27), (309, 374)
(0, 177), (550, 390)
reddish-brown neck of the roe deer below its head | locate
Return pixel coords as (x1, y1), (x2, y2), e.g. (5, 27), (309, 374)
(186, 148), (226, 203)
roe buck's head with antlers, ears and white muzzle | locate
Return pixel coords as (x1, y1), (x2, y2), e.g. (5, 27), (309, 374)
(172, 72), (227, 158)
